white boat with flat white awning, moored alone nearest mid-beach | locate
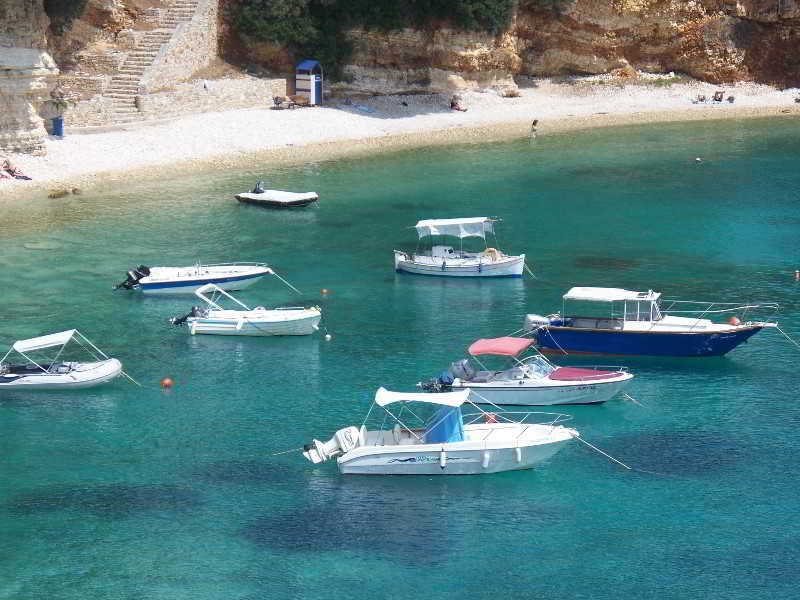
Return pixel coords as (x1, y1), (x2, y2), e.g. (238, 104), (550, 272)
(394, 217), (525, 277)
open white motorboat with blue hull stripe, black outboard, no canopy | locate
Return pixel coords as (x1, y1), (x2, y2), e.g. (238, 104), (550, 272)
(114, 262), (273, 294)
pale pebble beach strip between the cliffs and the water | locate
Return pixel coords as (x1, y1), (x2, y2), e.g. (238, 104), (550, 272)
(0, 76), (800, 200)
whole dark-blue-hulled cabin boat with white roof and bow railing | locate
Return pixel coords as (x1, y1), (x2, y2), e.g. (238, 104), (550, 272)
(523, 287), (778, 356)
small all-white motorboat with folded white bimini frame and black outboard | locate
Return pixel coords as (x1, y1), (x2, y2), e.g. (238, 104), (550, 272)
(170, 283), (322, 336)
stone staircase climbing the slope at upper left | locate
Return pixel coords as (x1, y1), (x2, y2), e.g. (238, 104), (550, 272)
(103, 0), (198, 123)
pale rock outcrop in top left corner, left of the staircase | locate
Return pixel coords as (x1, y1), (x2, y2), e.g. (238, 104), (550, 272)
(0, 0), (58, 153)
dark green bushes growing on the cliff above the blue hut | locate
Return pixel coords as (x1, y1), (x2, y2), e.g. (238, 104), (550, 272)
(232, 0), (514, 78)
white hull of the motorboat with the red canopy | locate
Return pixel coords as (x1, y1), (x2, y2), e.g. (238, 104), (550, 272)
(451, 373), (633, 406)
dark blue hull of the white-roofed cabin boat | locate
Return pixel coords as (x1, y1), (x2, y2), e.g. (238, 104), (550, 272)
(535, 325), (763, 356)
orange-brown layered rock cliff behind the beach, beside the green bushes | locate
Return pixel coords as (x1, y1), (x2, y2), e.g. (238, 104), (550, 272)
(230, 0), (800, 93)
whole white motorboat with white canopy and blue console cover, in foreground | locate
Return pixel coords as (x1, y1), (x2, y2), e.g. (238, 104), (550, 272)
(303, 388), (579, 475)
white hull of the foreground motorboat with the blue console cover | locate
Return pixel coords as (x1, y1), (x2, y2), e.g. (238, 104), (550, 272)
(337, 438), (570, 475)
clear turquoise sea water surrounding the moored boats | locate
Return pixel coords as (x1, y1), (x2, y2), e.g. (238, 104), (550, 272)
(0, 119), (800, 600)
